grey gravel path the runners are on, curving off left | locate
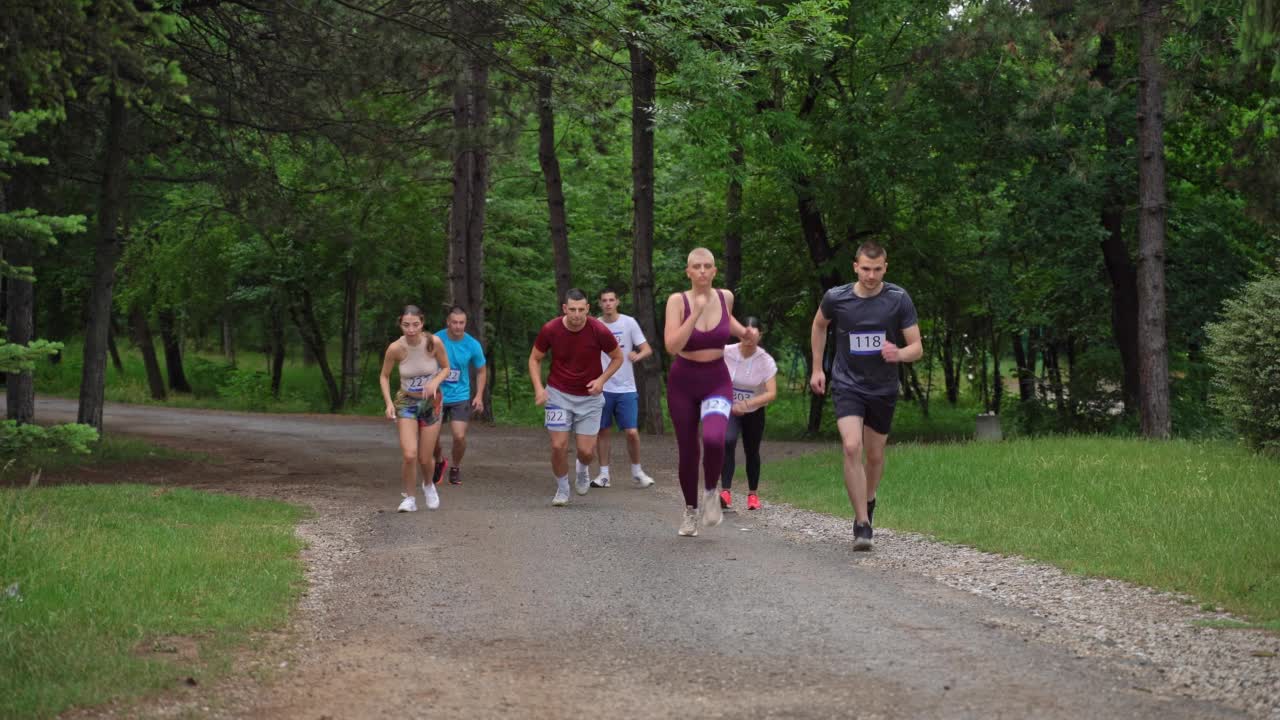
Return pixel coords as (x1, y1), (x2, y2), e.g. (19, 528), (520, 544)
(40, 402), (1280, 719)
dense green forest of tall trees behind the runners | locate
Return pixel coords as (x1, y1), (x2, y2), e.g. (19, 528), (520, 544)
(0, 0), (1280, 437)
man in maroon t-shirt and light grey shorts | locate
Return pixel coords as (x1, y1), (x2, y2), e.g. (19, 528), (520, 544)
(529, 287), (622, 507)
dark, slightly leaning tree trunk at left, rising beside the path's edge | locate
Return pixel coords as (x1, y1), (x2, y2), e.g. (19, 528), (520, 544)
(77, 87), (128, 433)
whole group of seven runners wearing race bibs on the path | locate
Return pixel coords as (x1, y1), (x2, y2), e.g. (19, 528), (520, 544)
(381, 242), (923, 550)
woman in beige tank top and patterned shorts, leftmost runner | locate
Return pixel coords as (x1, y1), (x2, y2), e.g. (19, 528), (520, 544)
(378, 305), (449, 512)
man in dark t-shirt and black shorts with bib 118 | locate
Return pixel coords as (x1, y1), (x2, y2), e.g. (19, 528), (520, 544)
(809, 242), (924, 550)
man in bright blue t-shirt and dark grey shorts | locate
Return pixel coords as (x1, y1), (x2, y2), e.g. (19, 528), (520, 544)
(433, 305), (488, 486)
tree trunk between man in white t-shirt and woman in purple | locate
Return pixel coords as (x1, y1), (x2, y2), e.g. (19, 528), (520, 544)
(628, 36), (666, 434)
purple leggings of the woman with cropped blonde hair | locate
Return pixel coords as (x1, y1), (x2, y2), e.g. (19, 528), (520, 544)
(667, 356), (733, 507)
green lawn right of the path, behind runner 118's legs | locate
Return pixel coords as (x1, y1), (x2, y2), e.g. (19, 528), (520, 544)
(763, 437), (1280, 630)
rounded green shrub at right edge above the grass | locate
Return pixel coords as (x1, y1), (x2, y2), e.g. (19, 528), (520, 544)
(1207, 275), (1280, 452)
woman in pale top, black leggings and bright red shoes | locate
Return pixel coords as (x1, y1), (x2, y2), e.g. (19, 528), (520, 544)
(719, 318), (778, 510)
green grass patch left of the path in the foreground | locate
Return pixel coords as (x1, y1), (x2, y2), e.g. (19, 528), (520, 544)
(0, 486), (305, 717)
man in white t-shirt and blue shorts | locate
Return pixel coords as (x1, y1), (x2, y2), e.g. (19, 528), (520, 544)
(579, 288), (653, 488)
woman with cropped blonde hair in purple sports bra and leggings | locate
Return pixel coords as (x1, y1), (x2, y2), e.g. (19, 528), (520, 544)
(663, 247), (746, 537)
